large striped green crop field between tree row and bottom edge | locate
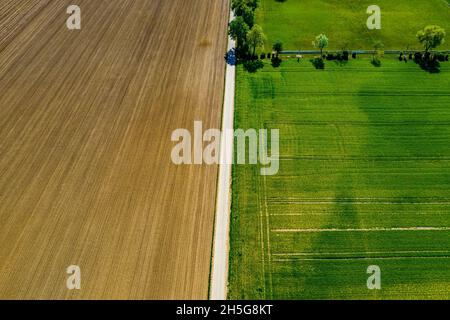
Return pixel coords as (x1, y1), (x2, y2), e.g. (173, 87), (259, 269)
(229, 58), (450, 299)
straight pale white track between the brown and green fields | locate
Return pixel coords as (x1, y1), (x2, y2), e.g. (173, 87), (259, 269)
(210, 10), (236, 300)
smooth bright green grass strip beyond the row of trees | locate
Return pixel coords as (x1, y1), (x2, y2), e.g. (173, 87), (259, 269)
(257, 0), (450, 51)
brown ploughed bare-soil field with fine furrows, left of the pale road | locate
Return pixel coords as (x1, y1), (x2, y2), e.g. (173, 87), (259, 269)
(0, 0), (228, 299)
